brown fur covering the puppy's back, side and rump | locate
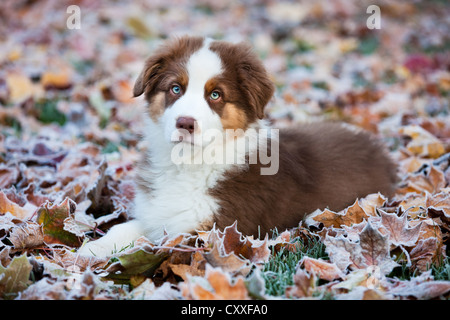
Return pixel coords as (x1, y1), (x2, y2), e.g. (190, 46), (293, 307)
(210, 123), (396, 236)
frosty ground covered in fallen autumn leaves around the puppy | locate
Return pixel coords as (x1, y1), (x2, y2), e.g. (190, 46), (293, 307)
(0, 1), (450, 299)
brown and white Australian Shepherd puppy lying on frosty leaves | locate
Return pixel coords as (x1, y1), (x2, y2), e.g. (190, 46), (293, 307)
(81, 37), (396, 256)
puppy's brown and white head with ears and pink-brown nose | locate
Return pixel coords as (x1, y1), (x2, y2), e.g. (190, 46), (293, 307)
(134, 37), (274, 146)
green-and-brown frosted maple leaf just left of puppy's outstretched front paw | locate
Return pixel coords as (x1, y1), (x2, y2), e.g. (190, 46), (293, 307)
(37, 198), (81, 247)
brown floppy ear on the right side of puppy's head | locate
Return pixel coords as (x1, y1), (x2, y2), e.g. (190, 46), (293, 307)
(238, 44), (275, 119)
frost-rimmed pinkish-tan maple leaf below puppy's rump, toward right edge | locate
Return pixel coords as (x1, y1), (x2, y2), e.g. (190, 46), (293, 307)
(378, 210), (421, 247)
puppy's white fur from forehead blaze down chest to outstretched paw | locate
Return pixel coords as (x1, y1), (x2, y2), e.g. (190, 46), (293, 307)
(81, 42), (263, 256)
